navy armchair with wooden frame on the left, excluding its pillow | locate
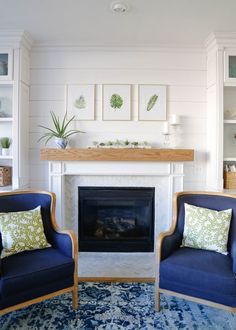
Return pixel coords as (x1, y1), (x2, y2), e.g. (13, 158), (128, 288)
(0, 191), (78, 315)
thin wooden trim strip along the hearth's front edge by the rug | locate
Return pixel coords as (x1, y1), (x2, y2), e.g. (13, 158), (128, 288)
(78, 277), (155, 283)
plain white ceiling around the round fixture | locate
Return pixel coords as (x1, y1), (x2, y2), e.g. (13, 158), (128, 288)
(0, 0), (236, 47)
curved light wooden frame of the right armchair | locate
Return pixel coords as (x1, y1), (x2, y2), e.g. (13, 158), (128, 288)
(155, 191), (236, 313)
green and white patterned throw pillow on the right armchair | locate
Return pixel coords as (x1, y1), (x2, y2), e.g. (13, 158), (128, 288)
(181, 203), (232, 254)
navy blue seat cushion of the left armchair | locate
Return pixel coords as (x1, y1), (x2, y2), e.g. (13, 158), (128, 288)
(0, 248), (74, 299)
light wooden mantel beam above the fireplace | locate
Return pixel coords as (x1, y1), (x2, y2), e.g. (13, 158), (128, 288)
(40, 148), (194, 162)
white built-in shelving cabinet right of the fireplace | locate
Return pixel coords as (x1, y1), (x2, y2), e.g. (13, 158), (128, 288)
(206, 33), (236, 193)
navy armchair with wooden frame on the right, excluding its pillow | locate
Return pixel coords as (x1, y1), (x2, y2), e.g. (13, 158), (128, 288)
(156, 192), (236, 312)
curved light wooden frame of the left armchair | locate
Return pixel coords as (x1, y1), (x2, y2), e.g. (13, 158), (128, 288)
(0, 190), (78, 315)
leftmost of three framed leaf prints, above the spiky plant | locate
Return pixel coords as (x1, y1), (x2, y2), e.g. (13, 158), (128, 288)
(66, 84), (95, 120)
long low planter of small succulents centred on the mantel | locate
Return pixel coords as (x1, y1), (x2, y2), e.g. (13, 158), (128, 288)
(93, 140), (152, 149)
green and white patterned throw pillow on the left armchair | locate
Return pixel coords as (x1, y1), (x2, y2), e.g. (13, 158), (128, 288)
(0, 206), (50, 258)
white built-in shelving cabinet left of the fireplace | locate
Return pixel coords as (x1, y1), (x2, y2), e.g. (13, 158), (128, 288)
(0, 31), (32, 191)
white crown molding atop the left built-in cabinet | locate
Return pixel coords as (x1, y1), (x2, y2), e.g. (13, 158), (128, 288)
(0, 30), (33, 50)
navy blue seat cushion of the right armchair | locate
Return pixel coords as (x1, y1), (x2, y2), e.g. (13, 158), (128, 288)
(160, 248), (236, 306)
